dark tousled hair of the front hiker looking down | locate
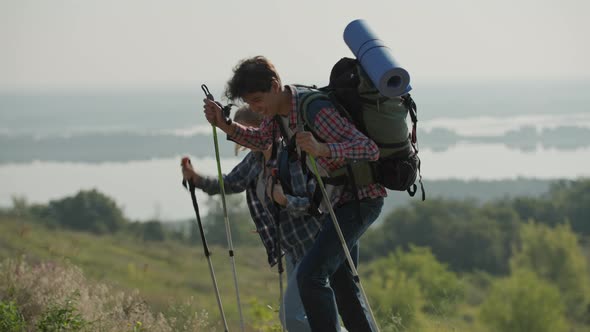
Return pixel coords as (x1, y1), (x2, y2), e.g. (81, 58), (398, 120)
(225, 55), (281, 100)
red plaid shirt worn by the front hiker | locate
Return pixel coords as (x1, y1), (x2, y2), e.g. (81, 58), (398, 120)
(230, 86), (387, 203)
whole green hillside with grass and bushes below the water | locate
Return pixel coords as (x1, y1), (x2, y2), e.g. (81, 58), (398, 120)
(0, 179), (590, 332)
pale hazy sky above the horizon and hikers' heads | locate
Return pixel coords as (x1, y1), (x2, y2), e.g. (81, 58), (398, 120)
(0, 0), (590, 90)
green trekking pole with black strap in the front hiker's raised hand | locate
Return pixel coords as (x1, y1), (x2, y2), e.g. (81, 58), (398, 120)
(201, 84), (244, 332)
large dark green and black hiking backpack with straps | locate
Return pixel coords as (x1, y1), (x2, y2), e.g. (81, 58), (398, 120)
(297, 58), (426, 200)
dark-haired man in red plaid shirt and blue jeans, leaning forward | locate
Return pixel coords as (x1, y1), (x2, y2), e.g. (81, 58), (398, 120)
(204, 56), (387, 332)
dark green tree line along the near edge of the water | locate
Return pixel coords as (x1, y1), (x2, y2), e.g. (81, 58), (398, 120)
(1, 179), (590, 275)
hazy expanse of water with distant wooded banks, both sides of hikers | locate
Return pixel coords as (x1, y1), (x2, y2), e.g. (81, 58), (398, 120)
(0, 82), (590, 220)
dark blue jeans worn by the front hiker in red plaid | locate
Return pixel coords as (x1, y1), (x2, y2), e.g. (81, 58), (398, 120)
(297, 198), (383, 332)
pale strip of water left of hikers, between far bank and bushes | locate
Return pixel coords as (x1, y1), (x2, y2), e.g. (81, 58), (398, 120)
(0, 156), (240, 220)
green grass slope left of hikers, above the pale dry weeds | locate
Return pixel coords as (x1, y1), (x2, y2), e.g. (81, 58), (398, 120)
(0, 218), (279, 329)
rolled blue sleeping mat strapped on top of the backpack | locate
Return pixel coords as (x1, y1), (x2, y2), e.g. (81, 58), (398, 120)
(344, 20), (412, 97)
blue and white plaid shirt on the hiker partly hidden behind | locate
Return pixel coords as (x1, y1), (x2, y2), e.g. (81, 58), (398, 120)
(195, 152), (321, 266)
